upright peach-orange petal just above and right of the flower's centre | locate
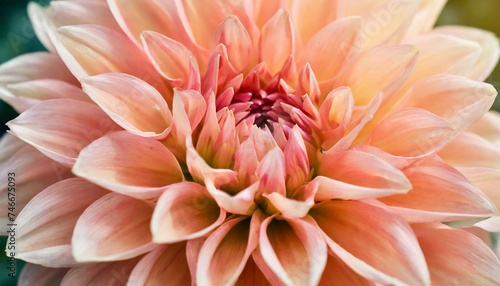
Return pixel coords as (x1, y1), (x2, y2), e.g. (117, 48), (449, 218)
(301, 16), (361, 82)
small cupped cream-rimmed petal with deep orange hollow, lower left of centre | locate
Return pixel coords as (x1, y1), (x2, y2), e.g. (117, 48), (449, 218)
(151, 182), (226, 243)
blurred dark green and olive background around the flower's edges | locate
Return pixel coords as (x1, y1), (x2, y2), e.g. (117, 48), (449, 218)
(0, 0), (500, 286)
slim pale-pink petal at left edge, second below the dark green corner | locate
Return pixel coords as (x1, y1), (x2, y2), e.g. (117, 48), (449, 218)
(0, 79), (92, 113)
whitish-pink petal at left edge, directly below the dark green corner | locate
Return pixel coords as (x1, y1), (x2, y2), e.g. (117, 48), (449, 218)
(0, 52), (78, 85)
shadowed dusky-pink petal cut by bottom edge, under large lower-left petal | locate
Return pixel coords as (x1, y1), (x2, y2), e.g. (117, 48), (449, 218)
(61, 257), (141, 286)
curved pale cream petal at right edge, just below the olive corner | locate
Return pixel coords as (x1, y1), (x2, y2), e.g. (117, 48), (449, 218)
(433, 25), (500, 81)
